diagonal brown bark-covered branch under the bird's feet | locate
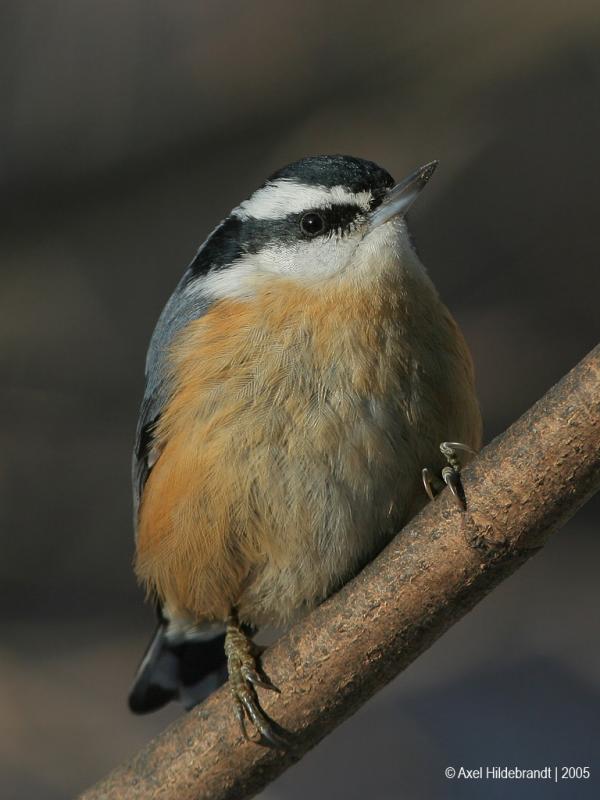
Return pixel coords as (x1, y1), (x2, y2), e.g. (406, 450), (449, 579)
(83, 346), (600, 800)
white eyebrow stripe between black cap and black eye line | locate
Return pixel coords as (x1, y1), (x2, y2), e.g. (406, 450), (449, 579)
(231, 178), (372, 220)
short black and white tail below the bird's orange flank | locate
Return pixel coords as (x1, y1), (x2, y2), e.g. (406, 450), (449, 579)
(129, 619), (227, 714)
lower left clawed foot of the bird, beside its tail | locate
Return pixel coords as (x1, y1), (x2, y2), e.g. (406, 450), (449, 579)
(225, 613), (289, 750)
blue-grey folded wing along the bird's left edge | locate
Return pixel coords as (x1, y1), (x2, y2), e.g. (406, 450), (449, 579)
(132, 262), (212, 526)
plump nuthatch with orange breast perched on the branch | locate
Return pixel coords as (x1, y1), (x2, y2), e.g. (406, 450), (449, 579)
(129, 155), (482, 747)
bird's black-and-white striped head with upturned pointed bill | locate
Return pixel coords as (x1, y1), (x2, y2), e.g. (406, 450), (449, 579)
(189, 155), (437, 299)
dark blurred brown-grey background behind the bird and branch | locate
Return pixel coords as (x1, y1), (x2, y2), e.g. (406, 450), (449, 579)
(0, 0), (600, 800)
